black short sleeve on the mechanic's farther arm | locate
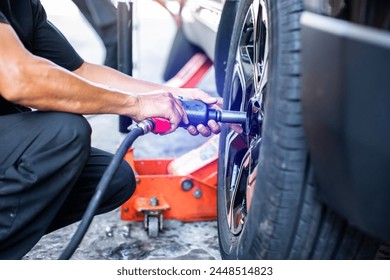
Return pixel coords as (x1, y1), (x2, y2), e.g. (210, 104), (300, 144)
(31, 1), (84, 71)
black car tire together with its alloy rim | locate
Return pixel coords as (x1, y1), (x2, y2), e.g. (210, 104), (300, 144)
(218, 0), (380, 260)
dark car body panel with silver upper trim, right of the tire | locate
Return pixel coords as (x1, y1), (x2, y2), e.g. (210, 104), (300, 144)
(302, 12), (390, 241)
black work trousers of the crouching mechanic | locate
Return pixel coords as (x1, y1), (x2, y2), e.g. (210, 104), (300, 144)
(0, 111), (135, 259)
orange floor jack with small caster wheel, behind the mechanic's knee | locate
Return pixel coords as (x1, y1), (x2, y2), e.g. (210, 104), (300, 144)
(121, 54), (219, 237)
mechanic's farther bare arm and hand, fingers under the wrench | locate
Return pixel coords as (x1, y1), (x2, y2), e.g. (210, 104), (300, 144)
(74, 62), (222, 136)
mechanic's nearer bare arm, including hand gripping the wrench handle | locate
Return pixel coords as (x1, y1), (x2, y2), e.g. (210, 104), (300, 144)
(0, 23), (186, 135)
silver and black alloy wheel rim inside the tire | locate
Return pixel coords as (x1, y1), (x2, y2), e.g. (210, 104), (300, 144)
(224, 0), (268, 235)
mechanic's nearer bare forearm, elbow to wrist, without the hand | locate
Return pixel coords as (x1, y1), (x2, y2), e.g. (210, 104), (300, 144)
(3, 57), (137, 116)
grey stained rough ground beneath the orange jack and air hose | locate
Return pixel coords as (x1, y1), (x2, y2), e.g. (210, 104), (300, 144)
(24, 210), (220, 260)
